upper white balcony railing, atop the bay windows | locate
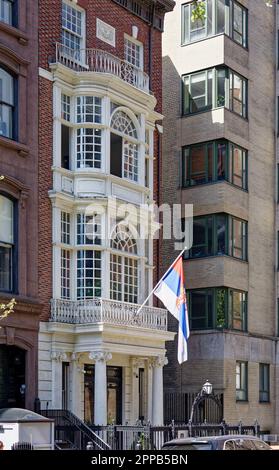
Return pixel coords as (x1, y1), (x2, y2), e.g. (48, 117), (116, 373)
(51, 43), (149, 93)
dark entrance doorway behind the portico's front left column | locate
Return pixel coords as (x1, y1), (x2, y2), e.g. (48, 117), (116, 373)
(84, 364), (122, 424)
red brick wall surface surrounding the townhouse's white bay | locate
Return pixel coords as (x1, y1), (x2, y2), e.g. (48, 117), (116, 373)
(39, 0), (170, 320)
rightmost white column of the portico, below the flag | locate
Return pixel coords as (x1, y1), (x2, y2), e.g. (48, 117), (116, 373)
(151, 356), (168, 426)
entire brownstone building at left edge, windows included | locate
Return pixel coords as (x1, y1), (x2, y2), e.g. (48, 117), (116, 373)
(0, 0), (40, 409)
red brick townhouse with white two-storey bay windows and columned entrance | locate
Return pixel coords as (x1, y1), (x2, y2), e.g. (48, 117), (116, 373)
(39, 0), (174, 424)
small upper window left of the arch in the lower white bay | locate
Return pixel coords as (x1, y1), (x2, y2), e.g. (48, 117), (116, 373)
(77, 214), (102, 245)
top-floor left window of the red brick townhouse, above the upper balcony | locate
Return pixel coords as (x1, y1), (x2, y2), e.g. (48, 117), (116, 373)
(62, 2), (85, 53)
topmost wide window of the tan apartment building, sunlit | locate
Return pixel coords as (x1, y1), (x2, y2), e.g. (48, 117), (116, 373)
(181, 0), (248, 47)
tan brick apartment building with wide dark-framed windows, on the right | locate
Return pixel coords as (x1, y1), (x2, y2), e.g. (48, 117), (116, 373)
(161, 0), (279, 431)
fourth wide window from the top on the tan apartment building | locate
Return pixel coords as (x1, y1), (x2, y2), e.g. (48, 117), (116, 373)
(185, 214), (248, 261)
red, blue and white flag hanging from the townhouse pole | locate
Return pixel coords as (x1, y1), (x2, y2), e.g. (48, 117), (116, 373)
(154, 256), (190, 364)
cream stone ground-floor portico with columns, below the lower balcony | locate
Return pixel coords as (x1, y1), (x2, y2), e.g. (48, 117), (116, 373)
(39, 323), (174, 425)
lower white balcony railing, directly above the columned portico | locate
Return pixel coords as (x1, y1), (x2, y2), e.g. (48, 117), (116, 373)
(51, 299), (168, 331)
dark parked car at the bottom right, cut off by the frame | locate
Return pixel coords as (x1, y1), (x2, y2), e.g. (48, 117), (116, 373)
(162, 434), (272, 450)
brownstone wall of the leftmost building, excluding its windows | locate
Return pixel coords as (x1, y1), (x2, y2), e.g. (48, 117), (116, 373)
(0, 0), (40, 409)
